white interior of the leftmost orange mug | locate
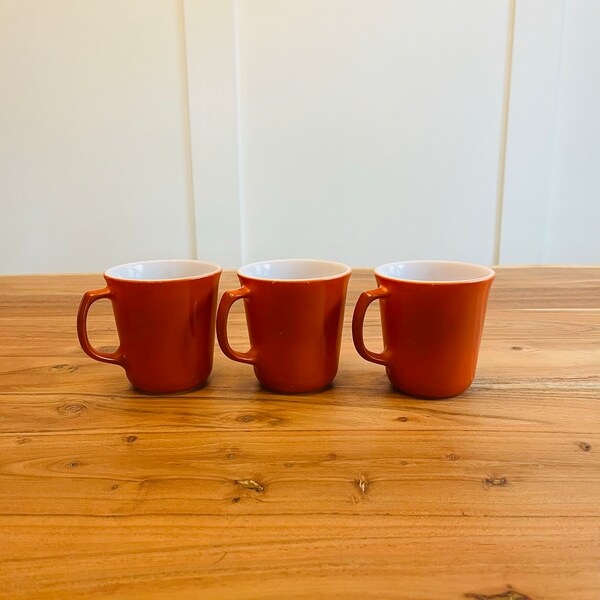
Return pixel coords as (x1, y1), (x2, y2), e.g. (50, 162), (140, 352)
(104, 259), (221, 281)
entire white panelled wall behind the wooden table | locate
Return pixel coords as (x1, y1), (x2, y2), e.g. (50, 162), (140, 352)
(0, 0), (600, 273)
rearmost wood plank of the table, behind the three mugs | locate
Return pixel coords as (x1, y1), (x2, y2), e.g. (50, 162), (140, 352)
(0, 268), (600, 386)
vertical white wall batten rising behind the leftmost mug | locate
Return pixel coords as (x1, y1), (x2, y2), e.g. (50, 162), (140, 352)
(184, 0), (242, 268)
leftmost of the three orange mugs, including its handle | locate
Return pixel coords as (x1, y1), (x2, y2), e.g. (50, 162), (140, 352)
(77, 260), (222, 394)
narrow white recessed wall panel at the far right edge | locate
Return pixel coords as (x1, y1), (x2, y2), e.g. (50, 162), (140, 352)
(544, 0), (600, 264)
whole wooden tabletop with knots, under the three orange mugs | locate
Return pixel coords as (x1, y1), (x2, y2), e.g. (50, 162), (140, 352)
(0, 267), (600, 600)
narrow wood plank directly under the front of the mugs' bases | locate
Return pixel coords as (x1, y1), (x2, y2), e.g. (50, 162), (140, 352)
(0, 386), (600, 436)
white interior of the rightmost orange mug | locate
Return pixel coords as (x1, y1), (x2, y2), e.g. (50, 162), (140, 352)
(375, 260), (495, 283)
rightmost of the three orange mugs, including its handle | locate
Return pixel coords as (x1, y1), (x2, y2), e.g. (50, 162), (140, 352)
(352, 260), (496, 398)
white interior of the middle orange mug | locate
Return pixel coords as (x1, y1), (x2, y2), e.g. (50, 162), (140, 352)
(238, 258), (352, 281)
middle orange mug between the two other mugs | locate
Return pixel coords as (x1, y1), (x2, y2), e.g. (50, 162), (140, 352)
(217, 259), (352, 394)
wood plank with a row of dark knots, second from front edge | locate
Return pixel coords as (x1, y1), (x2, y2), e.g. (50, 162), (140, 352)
(0, 427), (600, 517)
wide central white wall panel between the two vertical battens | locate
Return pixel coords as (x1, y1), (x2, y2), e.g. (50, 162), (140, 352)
(236, 0), (509, 266)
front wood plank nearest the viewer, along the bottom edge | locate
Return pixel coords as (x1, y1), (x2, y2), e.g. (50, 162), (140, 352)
(0, 514), (600, 600)
